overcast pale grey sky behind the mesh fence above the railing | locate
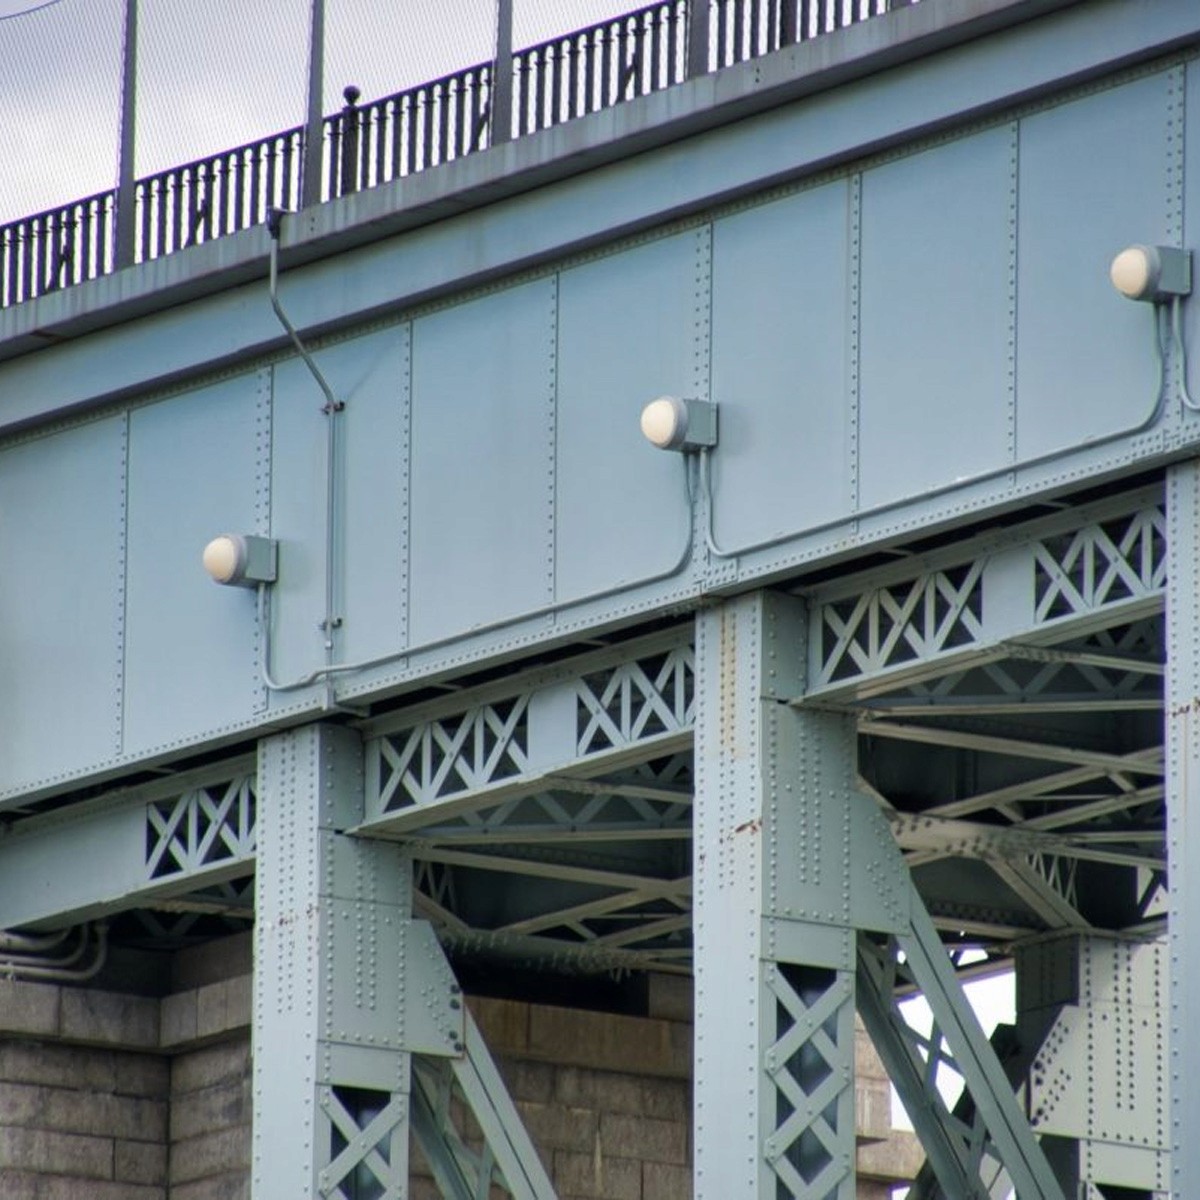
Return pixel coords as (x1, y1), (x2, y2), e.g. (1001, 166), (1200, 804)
(0, 0), (637, 223)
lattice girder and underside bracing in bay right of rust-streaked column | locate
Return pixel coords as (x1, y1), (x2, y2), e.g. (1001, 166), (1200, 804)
(804, 488), (1166, 941)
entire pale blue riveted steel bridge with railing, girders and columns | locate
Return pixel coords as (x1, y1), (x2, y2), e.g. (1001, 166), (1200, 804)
(0, 0), (1200, 1200)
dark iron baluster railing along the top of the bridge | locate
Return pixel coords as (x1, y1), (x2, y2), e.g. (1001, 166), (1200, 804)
(0, 0), (916, 307)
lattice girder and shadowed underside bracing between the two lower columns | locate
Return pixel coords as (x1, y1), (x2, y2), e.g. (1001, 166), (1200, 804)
(360, 629), (695, 970)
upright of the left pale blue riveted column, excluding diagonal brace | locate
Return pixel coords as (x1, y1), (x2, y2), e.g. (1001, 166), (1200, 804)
(252, 726), (422, 1200)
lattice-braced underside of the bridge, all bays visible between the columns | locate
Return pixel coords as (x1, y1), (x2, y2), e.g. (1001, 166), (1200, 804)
(0, 488), (1165, 971)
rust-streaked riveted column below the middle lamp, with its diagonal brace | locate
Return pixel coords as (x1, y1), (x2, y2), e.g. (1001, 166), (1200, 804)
(695, 593), (1062, 1200)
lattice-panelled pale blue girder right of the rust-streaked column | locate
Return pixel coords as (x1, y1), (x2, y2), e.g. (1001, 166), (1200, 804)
(804, 487), (1166, 704)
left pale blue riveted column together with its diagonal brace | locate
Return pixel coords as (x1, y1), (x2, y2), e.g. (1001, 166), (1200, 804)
(252, 725), (554, 1200)
